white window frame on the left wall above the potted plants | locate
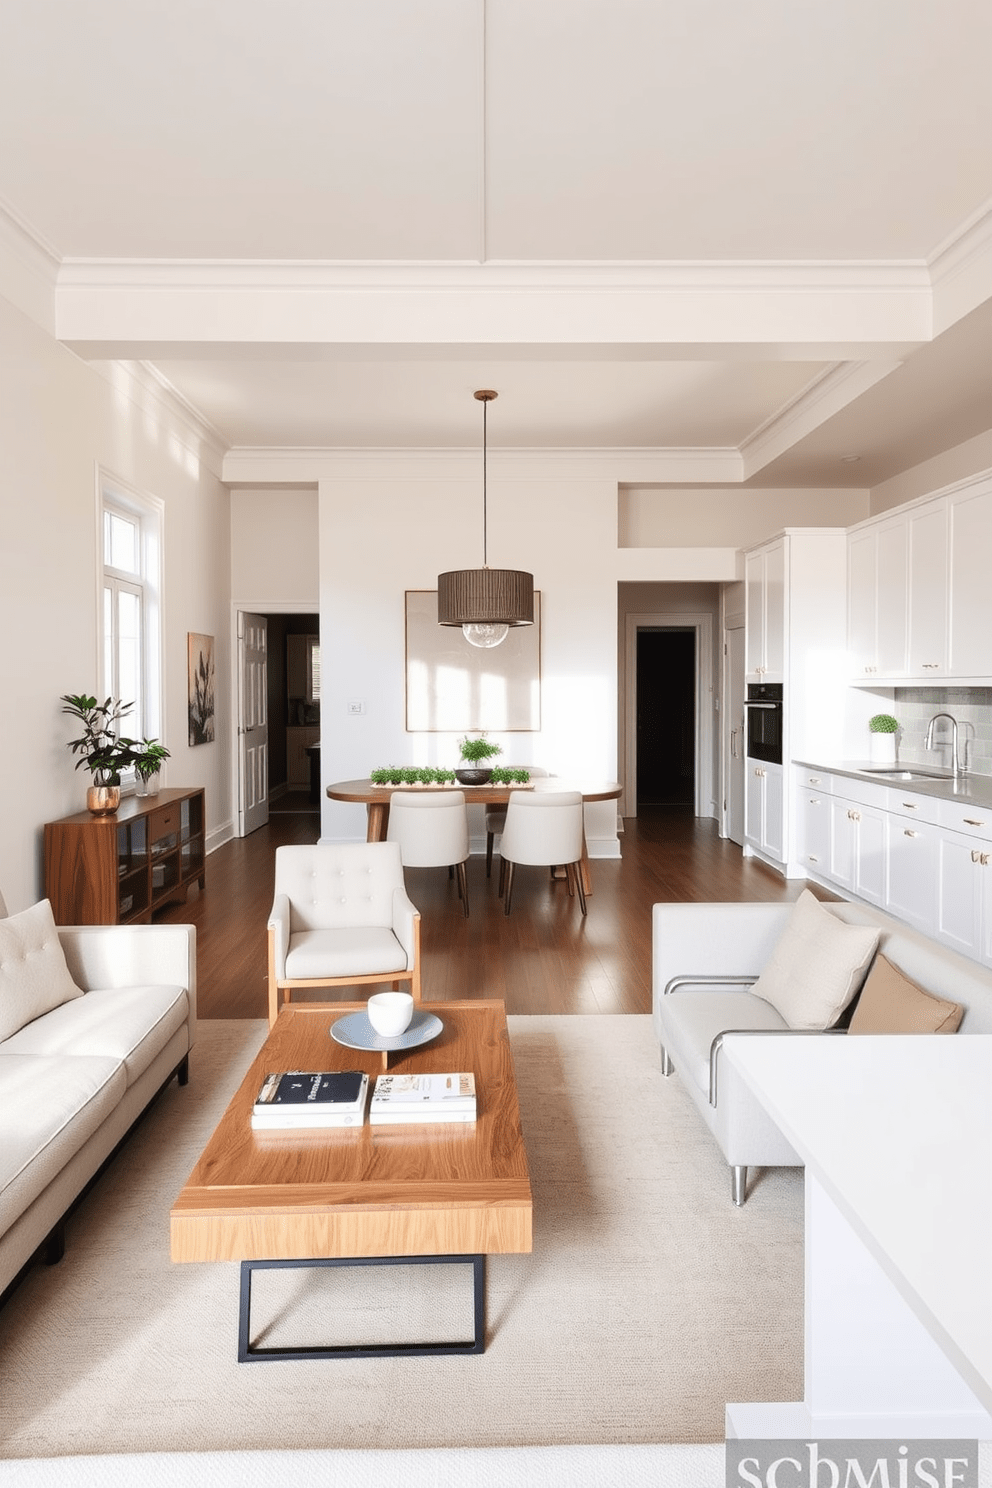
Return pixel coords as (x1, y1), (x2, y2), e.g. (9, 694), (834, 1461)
(97, 467), (165, 790)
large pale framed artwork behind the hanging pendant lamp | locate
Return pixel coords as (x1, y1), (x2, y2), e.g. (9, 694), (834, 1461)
(406, 589), (541, 734)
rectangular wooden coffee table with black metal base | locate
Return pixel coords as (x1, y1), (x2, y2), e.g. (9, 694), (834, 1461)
(171, 1000), (532, 1363)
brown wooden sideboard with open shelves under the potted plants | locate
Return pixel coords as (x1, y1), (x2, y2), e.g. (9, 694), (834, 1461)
(45, 789), (207, 926)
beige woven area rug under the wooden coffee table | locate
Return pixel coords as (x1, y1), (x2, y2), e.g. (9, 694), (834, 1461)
(0, 1015), (803, 1458)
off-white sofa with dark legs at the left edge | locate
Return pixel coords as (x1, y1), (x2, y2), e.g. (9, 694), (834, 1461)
(0, 899), (196, 1292)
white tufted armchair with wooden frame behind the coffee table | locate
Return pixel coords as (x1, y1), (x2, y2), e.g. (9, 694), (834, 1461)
(268, 842), (421, 1024)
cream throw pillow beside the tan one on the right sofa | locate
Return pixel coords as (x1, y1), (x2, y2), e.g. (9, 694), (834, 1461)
(751, 888), (879, 1028)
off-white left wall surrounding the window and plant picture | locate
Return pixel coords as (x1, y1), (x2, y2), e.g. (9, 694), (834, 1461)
(0, 298), (231, 911)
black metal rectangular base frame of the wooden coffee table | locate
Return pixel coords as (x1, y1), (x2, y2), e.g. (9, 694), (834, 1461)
(238, 1256), (486, 1364)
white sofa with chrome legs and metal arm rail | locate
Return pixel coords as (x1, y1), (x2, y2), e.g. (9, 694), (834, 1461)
(651, 902), (992, 1204)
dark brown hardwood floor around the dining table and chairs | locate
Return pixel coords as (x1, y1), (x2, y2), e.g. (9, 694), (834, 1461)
(161, 796), (806, 1018)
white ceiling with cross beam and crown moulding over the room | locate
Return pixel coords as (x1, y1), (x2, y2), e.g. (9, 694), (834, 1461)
(0, 0), (992, 487)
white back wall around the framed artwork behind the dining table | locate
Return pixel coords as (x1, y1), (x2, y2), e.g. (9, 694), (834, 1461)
(320, 451), (617, 854)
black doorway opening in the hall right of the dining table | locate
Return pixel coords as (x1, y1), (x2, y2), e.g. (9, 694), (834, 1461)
(635, 626), (696, 809)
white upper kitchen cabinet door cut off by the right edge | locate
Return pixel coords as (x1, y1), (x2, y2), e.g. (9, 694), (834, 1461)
(947, 479), (992, 677)
